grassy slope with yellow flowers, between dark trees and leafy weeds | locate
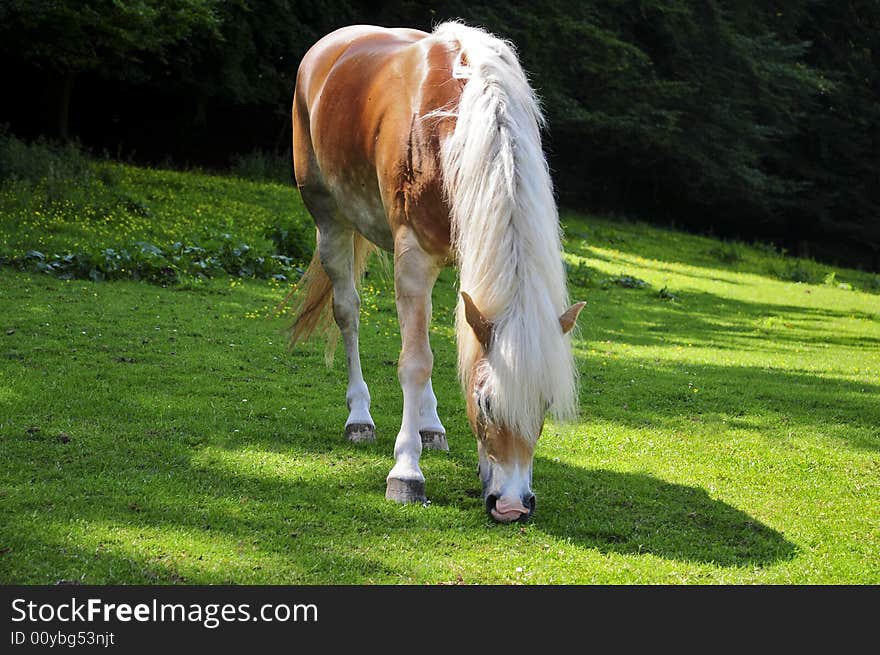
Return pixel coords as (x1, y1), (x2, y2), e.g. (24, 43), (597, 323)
(0, 162), (305, 252)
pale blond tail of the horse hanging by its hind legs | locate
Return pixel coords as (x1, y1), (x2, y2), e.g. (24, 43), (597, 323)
(284, 232), (376, 366)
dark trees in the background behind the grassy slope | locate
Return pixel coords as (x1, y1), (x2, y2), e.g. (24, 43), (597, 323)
(0, 0), (880, 270)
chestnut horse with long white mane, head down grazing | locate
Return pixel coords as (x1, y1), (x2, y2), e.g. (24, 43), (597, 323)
(291, 22), (583, 522)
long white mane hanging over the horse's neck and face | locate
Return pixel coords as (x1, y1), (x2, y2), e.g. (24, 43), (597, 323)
(433, 22), (577, 442)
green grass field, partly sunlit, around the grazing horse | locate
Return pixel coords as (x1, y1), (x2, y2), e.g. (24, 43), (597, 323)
(0, 163), (880, 584)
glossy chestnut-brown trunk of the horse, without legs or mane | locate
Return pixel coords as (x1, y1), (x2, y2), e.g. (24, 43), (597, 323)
(293, 26), (463, 257)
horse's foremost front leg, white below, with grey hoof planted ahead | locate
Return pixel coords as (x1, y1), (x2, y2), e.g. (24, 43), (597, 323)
(385, 227), (442, 503)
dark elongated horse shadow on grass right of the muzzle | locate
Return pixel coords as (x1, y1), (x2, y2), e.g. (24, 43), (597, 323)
(534, 457), (797, 566)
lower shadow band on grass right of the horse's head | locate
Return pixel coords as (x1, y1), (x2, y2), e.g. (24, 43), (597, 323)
(579, 355), (880, 450)
